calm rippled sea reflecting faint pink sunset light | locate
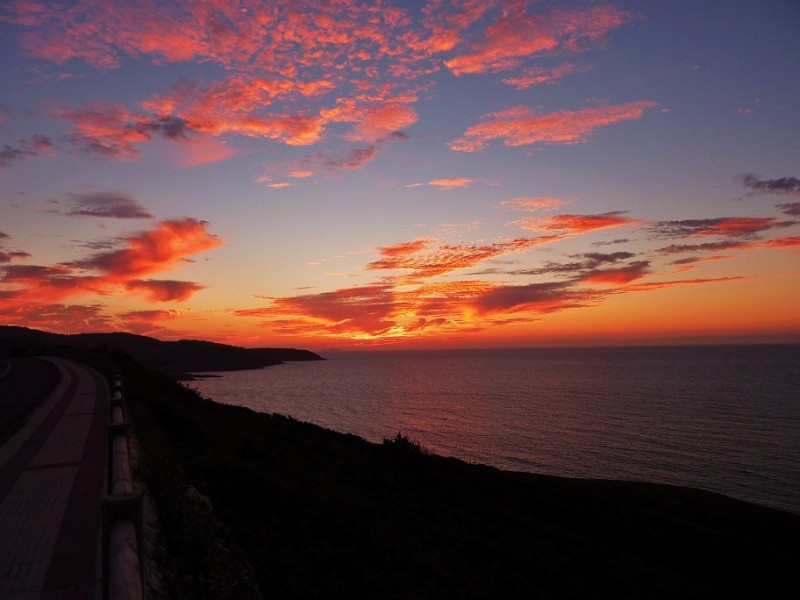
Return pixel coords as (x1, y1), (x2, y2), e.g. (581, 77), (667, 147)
(192, 345), (800, 513)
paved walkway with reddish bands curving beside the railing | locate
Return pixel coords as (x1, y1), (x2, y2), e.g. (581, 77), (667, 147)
(0, 358), (108, 600)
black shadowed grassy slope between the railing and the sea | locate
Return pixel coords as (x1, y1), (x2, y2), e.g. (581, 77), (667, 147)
(119, 362), (800, 598)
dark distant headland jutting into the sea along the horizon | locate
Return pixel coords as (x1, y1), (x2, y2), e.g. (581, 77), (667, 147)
(0, 325), (324, 379)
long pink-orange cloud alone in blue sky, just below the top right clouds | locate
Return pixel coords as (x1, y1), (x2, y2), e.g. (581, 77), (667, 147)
(450, 102), (656, 152)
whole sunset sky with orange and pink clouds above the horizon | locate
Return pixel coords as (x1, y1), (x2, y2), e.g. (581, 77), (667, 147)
(0, 0), (800, 351)
